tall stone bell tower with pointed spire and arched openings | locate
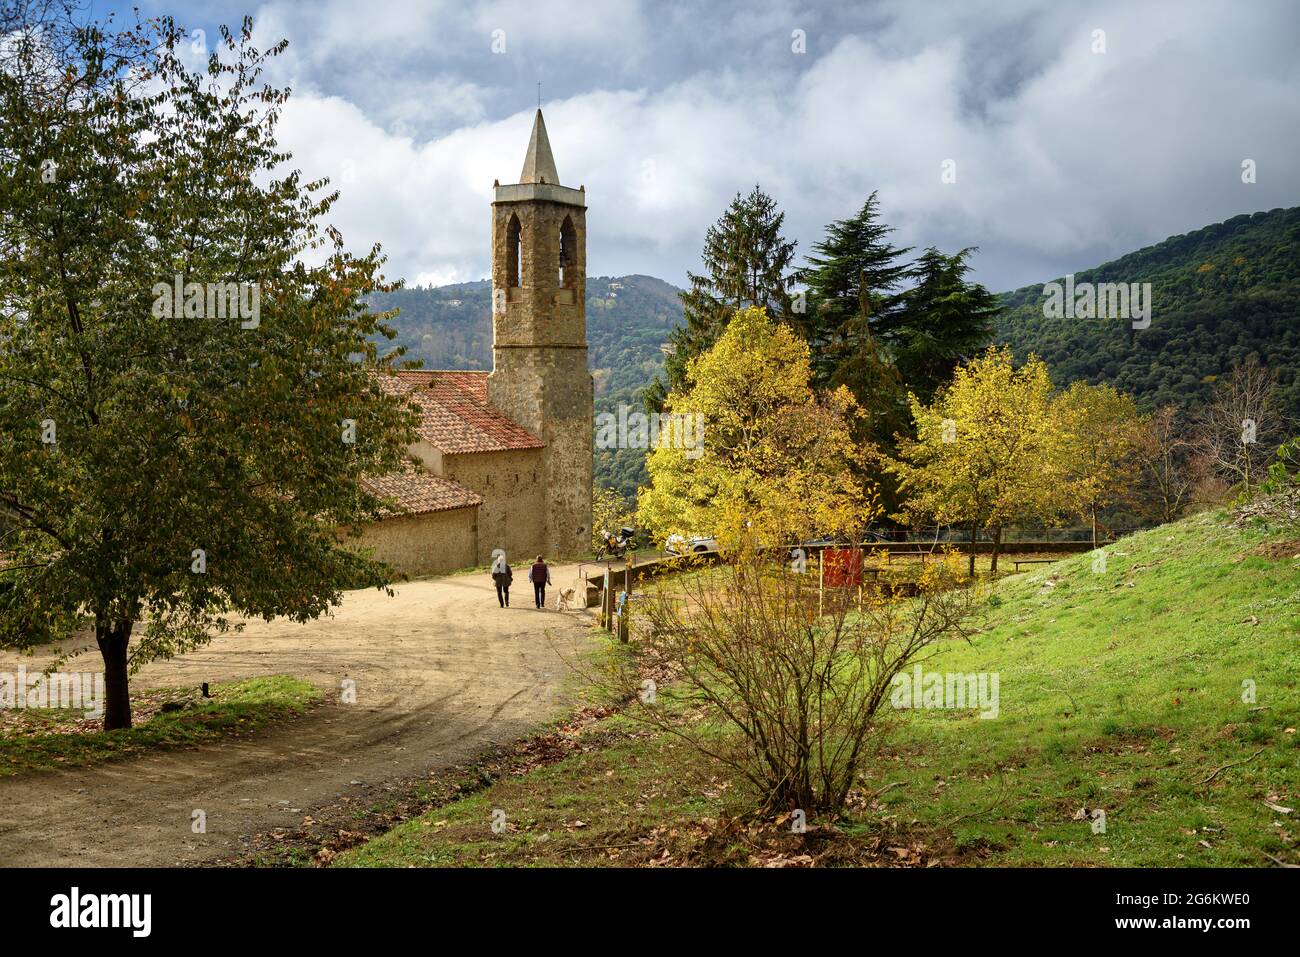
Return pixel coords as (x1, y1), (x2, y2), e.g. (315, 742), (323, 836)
(488, 109), (592, 557)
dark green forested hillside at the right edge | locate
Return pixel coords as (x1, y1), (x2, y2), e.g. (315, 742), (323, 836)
(997, 207), (1300, 417)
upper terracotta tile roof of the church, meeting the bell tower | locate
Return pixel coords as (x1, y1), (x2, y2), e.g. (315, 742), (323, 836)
(384, 371), (542, 454)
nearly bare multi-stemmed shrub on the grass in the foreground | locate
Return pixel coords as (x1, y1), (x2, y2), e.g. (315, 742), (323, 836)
(623, 551), (975, 813)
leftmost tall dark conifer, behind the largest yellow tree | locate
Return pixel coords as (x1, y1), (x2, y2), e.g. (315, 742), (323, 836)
(645, 186), (794, 411)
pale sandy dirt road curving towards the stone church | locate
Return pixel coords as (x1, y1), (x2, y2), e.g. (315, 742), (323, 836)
(0, 566), (592, 866)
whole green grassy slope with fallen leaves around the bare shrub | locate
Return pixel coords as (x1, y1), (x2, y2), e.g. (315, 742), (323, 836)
(335, 512), (1300, 867)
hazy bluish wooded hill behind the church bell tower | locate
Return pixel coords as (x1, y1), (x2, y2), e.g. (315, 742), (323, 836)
(374, 276), (681, 498)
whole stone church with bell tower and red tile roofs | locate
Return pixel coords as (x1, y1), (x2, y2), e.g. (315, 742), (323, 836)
(360, 109), (593, 576)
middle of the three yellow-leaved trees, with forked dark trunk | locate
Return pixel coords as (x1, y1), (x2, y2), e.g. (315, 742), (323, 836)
(889, 346), (1062, 575)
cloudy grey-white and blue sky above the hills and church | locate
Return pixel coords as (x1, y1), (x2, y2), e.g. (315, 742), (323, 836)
(94, 0), (1300, 290)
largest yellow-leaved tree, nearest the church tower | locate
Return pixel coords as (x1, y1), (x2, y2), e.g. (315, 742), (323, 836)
(637, 307), (878, 551)
